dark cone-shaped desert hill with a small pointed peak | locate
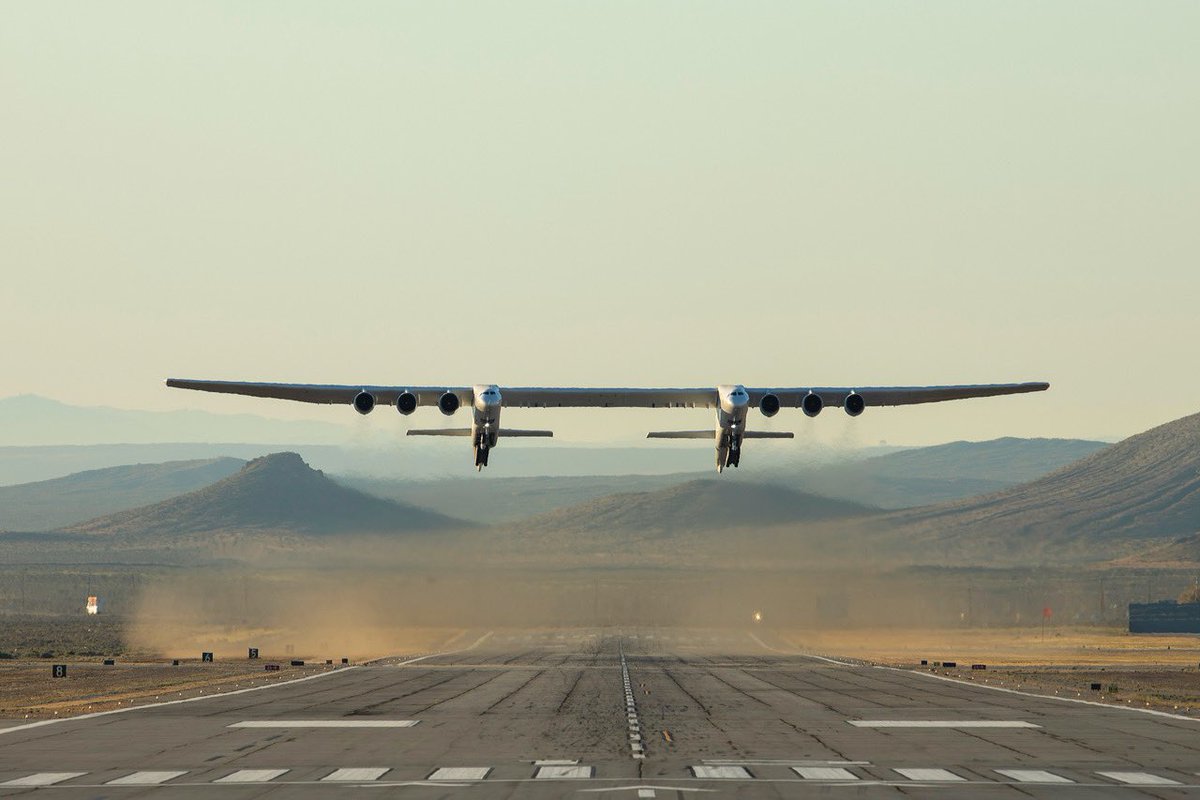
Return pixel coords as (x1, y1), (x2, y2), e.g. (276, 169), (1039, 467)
(66, 452), (467, 539)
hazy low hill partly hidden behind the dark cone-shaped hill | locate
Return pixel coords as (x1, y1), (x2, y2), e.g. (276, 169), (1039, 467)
(0, 458), (246, 531)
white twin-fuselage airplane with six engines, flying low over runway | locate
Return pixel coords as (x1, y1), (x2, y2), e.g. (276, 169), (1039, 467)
(167, 378), (1050, 473)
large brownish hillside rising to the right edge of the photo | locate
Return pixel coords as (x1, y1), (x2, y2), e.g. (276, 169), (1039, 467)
(887, 414), (1200, 563)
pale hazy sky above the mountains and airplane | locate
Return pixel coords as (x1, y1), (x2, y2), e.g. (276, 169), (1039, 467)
(0, 0), (1200, 444)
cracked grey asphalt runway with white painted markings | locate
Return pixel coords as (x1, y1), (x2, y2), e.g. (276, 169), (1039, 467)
(0, 631), (1200, 800)
